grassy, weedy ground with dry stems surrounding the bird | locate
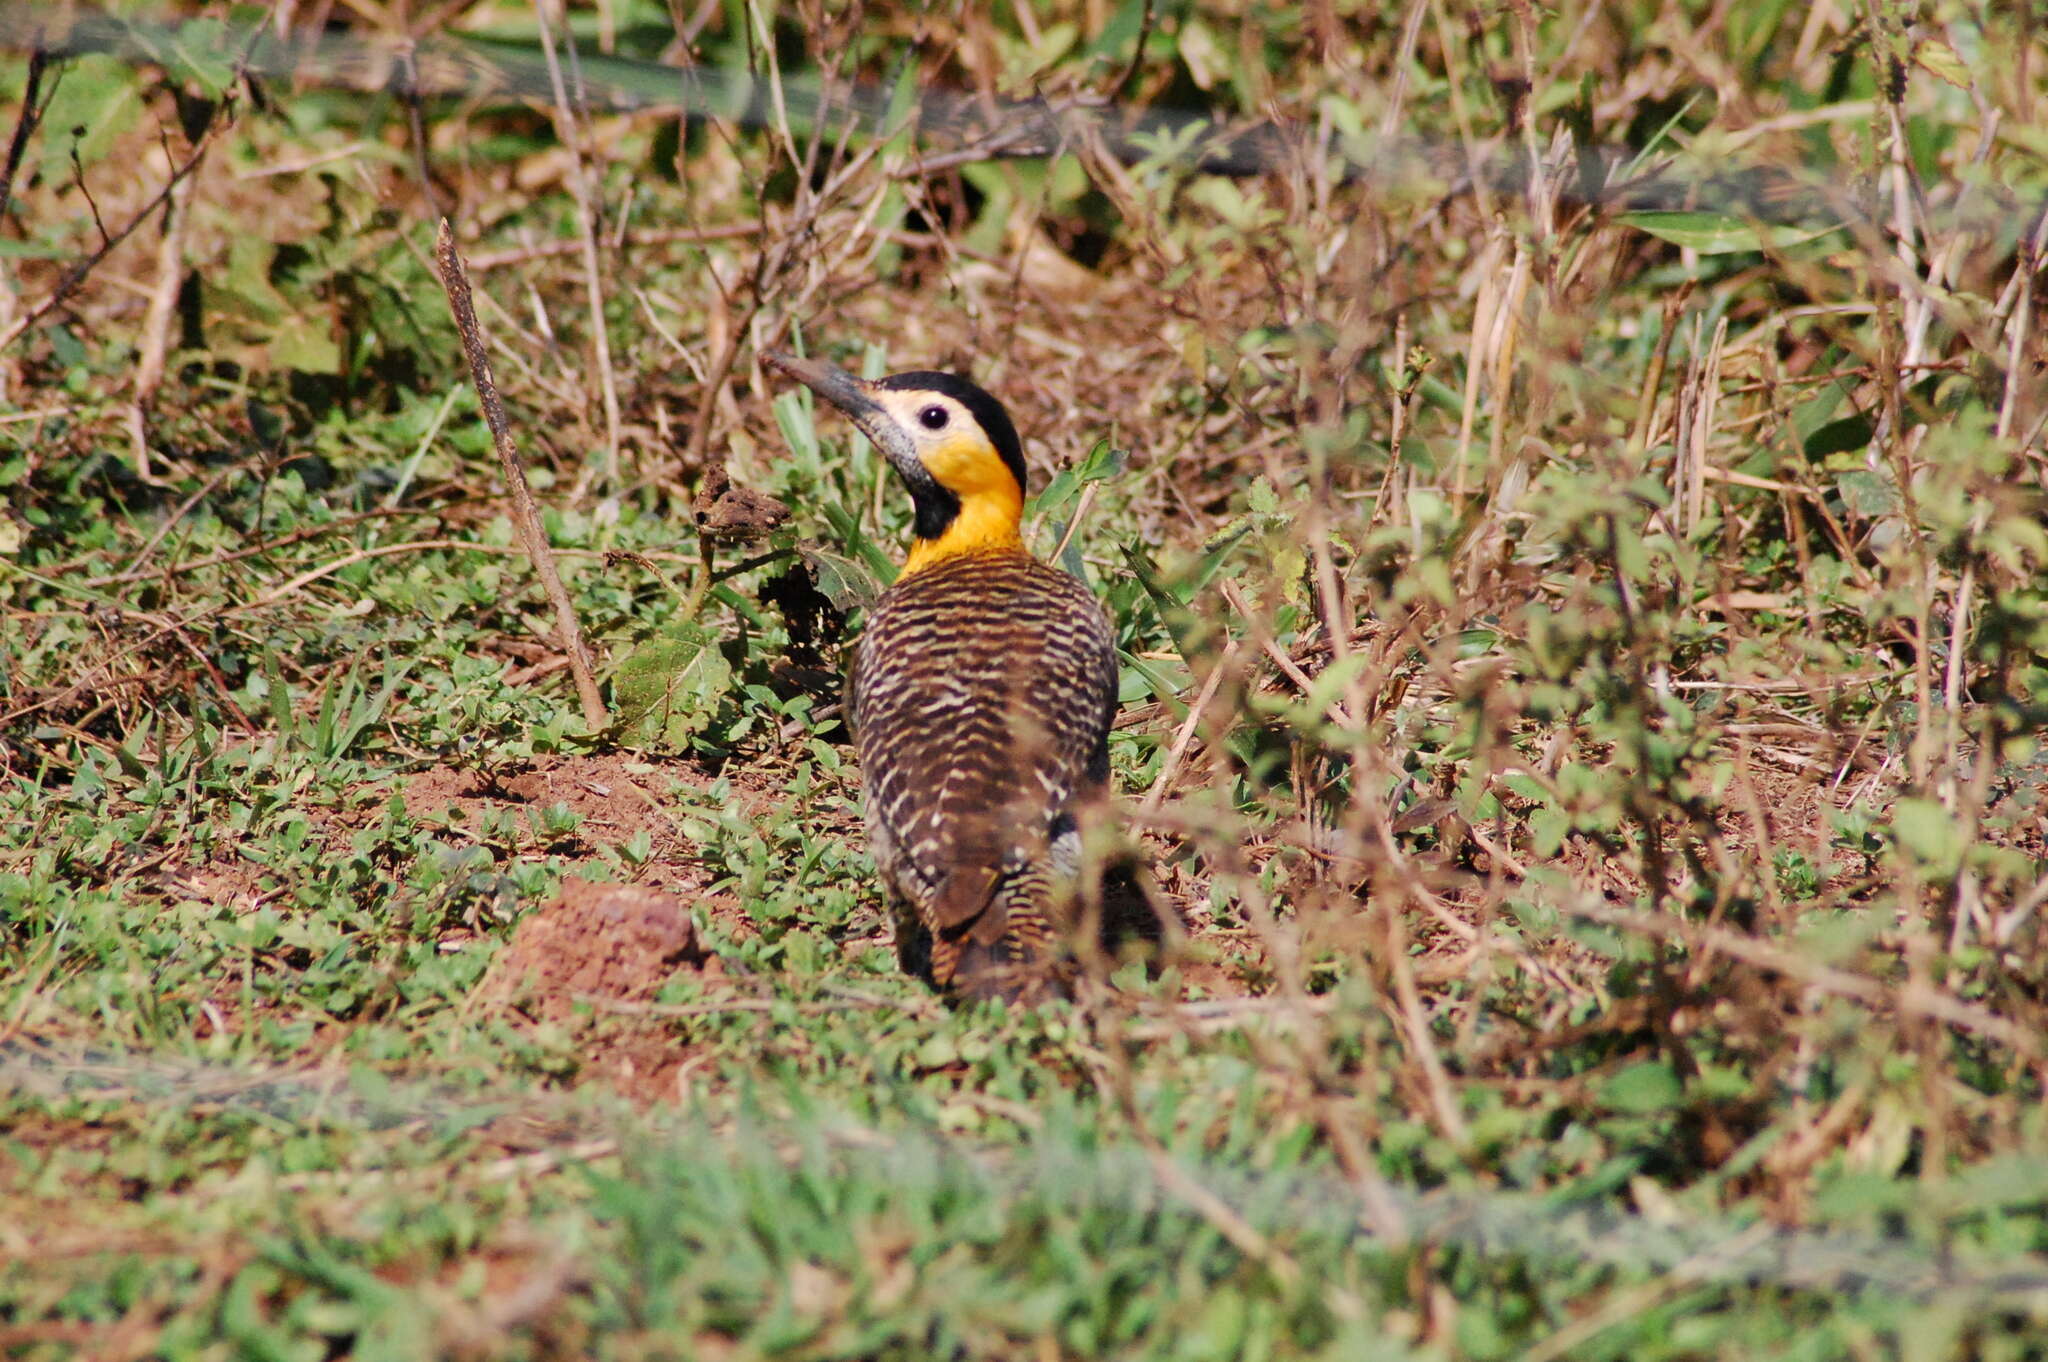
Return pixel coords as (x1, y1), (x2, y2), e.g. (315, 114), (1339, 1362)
(0, 0), (2048, 1360)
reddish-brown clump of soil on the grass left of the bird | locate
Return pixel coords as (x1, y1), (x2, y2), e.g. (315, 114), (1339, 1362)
(483, 879), (705, 1020)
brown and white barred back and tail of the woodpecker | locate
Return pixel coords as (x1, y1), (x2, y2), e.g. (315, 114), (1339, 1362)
(850, 549), (1116, 993)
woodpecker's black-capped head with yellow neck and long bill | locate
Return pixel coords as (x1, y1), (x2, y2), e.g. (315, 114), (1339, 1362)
(764, 354), (1024, 573)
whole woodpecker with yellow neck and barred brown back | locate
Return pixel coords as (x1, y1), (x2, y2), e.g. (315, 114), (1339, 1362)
(766, 354), (1155, 999)
